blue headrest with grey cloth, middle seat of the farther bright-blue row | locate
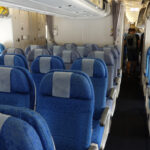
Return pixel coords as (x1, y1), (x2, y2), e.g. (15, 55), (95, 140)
(31, 56), (64, 74)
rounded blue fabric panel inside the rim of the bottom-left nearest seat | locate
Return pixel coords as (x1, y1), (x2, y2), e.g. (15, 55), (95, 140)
(0, 117), (43, 150)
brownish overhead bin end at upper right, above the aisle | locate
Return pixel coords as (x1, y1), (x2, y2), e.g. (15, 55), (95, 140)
(137, 8), (146, 28)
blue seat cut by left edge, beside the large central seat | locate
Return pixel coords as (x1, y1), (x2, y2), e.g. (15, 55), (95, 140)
(0, 66), (35, 109)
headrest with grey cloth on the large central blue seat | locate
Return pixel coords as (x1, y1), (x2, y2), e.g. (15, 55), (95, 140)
(40, 70), (93, 99)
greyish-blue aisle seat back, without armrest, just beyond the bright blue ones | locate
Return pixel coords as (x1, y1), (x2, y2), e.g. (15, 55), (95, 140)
(88, 51), (115, 94)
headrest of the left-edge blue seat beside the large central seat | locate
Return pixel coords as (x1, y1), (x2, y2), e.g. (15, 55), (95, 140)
(0, 67), (30, 93)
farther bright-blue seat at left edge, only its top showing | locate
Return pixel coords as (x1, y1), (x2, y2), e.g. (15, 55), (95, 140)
(0, 54), (28, 69)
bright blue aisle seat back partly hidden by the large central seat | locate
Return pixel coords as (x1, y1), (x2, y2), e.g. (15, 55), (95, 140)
(71, 58), (108, 120)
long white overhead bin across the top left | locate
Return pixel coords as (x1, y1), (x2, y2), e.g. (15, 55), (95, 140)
(0, 0), (111, 18)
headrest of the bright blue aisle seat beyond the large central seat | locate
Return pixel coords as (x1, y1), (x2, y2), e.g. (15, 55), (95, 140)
(71, 58), (107, 78)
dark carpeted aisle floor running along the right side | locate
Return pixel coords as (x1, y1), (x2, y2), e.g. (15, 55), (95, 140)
(105, 74), (150, 150)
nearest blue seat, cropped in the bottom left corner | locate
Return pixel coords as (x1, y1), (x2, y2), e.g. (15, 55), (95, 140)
(0, 105), (55, 150)
